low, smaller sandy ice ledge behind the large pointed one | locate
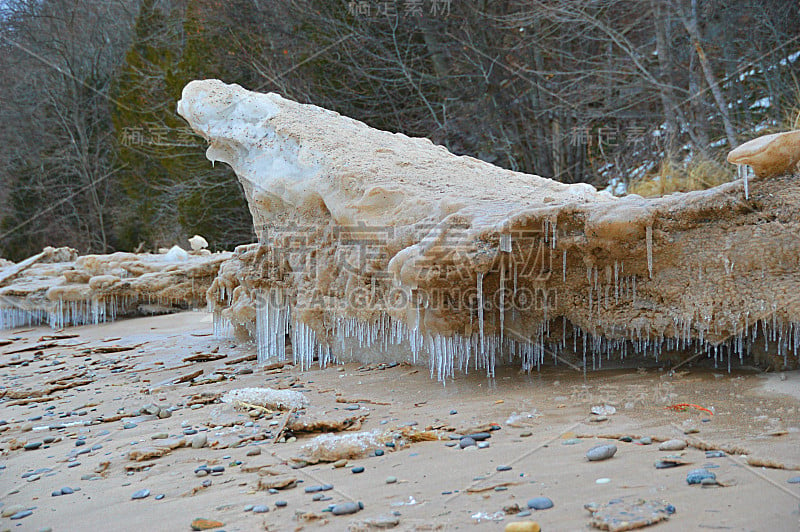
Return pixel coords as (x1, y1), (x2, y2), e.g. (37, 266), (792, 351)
(0, 246), (231, 329)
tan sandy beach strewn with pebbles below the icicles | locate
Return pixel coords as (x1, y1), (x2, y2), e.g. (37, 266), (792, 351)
(0, 312), (800, 531)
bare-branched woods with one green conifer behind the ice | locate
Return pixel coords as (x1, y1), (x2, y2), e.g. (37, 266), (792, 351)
(0, 0), (800, 260)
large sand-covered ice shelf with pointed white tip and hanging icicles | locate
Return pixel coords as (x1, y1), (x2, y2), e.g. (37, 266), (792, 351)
(178, 80), (800, 379)
